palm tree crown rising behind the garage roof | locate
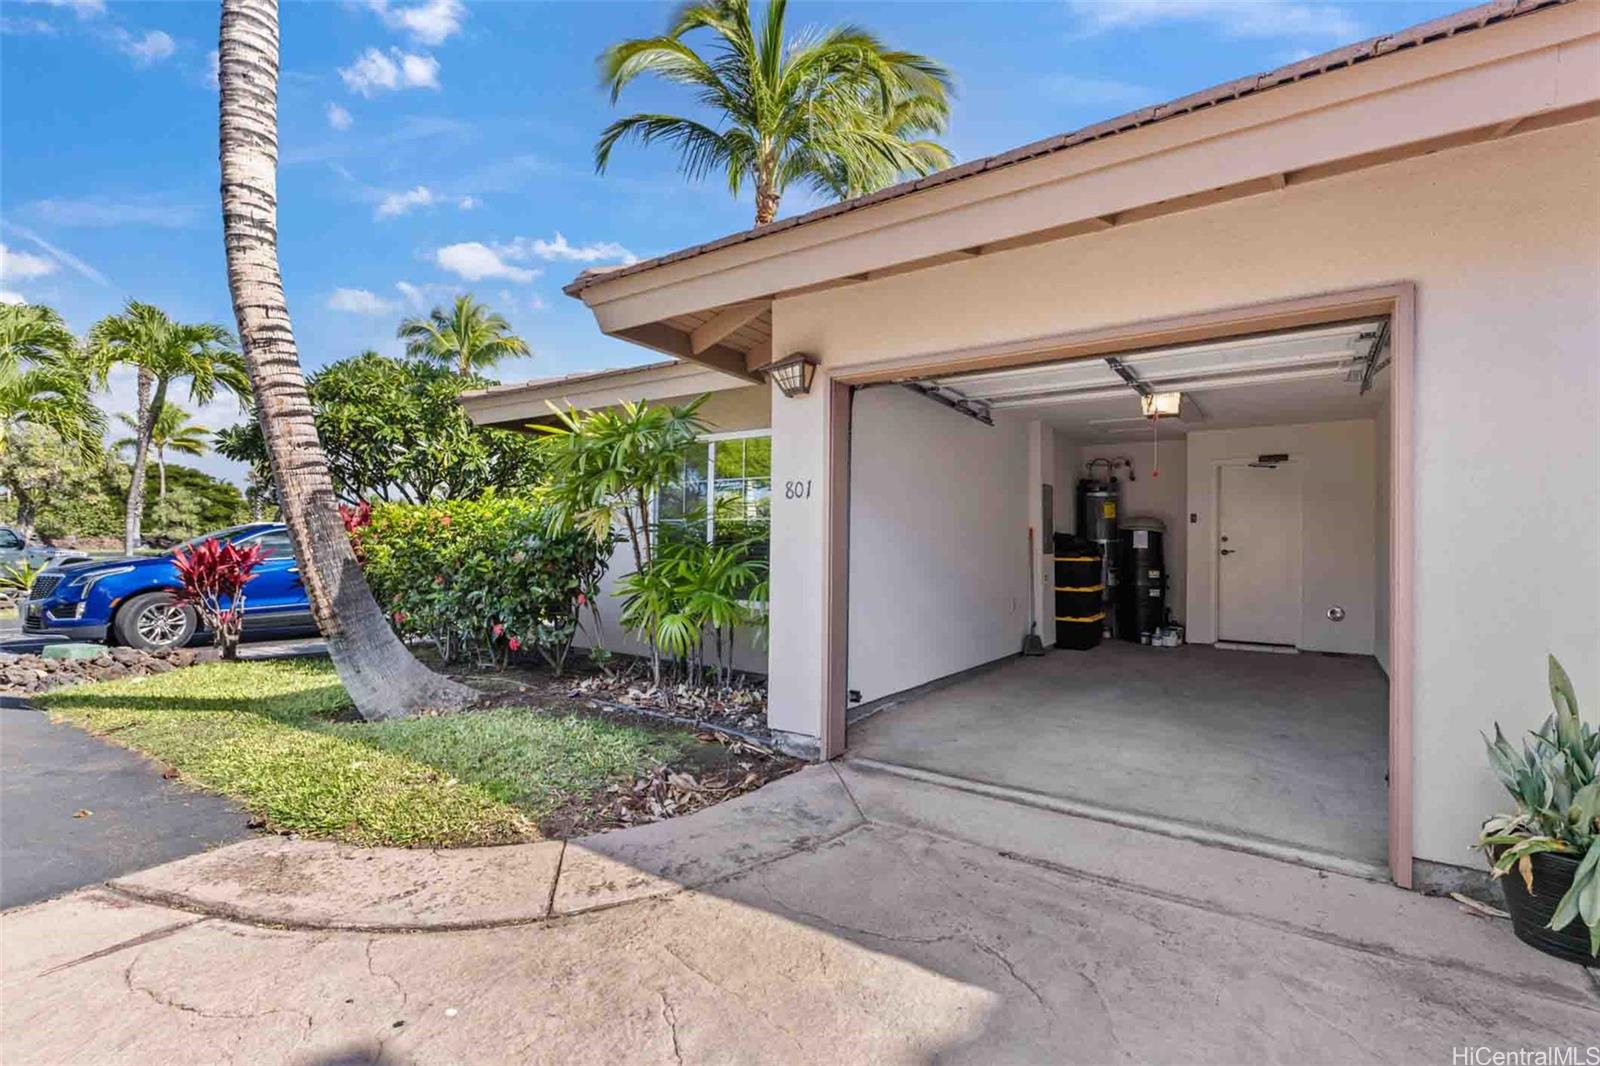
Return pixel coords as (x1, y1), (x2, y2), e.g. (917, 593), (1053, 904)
(595, 0), (950, 226)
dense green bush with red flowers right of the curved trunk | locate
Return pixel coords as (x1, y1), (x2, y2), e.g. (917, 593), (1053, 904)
(360, 493), (611, 674)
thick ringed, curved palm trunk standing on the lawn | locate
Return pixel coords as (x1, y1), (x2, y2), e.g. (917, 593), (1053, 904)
(218, 0), (475, 720)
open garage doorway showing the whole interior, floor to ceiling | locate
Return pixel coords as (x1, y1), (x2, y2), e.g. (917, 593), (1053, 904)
(846, 317), (1389, 876)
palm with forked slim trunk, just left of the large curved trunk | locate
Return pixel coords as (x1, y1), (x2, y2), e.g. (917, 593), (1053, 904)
(90, 299), (250, 555)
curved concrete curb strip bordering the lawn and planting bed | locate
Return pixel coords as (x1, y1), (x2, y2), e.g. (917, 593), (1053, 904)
(106, 765), (864, 933)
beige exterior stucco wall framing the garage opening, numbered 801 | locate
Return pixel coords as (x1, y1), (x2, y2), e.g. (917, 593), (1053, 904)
(773, 120), (1600, 863)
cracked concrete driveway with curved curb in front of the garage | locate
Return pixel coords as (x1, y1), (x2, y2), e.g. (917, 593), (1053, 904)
(0, 763), (1600, 1064)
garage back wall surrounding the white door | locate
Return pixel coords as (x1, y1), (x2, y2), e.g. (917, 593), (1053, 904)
(1187, 419), (1378, 655)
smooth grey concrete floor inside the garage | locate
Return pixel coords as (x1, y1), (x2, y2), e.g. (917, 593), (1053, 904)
(848, 642), (1389, 866)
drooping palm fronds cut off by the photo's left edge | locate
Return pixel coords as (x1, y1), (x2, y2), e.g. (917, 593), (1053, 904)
(0, 304), (106, 458)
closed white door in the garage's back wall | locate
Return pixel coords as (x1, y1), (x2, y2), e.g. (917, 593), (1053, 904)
(1216, 463), (1301, 645)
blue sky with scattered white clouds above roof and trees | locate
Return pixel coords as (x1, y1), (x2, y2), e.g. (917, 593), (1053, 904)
(0, 0), (1462, 475)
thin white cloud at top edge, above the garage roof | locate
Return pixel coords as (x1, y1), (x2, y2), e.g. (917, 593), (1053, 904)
(1067, 0), (1362, 40)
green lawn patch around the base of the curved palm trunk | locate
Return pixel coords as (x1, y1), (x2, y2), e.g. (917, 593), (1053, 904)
(35, 659), (693, 845)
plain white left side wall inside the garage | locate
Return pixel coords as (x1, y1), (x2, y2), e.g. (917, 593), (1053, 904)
(848, 386), (1034, 701)
